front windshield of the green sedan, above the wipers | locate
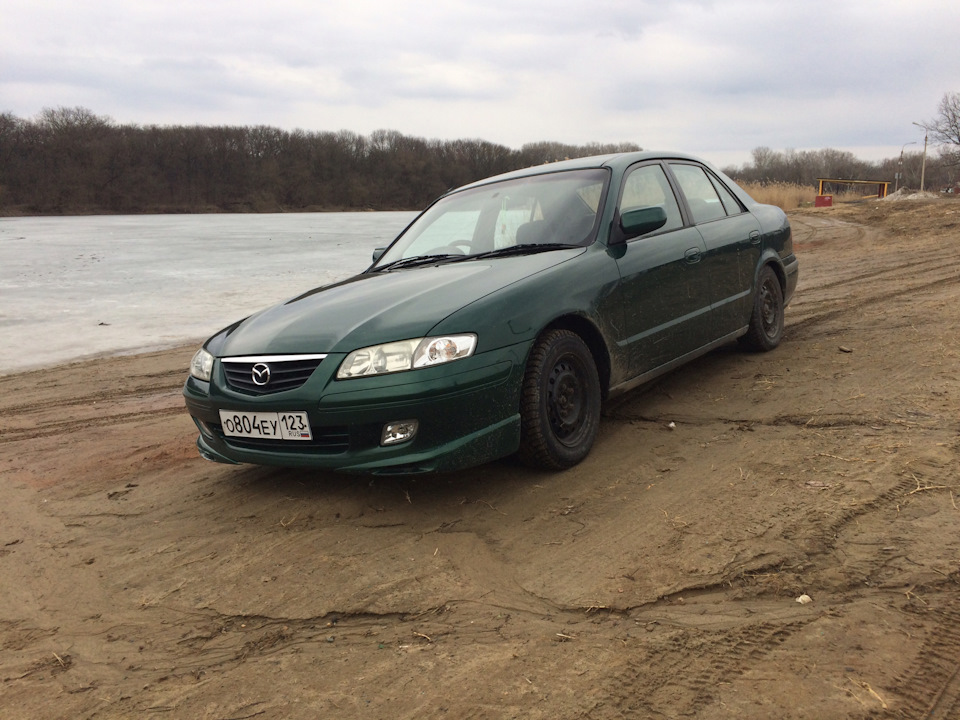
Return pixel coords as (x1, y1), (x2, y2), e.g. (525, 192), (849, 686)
(373, 169), (608, 270)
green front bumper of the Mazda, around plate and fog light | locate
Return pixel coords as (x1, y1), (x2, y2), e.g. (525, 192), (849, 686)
(183, 344), (529, 474)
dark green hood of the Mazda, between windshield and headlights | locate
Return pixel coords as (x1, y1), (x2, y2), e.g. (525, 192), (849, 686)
(209, 248), (584, 357)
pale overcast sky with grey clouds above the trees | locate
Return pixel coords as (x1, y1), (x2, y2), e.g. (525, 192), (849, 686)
(0, 0), (960, 165)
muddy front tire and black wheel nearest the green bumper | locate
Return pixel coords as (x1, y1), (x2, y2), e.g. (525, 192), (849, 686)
(518, 330), (600, 470)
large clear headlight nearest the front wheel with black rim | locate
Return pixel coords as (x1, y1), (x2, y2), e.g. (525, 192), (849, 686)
(337, 334), (477, 380)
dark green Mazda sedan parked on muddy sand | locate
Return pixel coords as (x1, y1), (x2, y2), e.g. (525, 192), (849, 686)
(183, 152), (798, 474)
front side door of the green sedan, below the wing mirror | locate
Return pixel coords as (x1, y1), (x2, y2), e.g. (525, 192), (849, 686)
(615, 162), (711, 380)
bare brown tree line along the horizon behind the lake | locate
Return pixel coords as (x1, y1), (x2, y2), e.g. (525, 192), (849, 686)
(0, 102), (958, 214)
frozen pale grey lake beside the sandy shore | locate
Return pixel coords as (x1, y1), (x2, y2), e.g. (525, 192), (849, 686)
(0, 212), (416, 375)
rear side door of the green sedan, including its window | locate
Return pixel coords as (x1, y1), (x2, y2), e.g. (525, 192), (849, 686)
(669, 162), (760, 334)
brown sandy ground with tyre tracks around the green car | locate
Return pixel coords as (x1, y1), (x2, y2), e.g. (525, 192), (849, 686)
(0, 200), (960, 720)
